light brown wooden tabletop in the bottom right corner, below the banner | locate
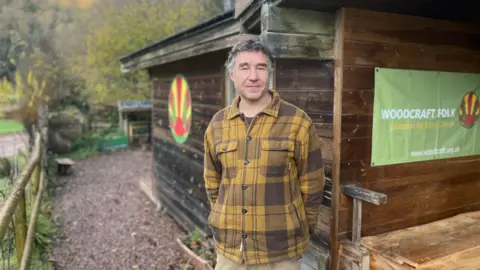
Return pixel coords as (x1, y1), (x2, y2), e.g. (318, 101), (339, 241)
(361, 212), (480, 269)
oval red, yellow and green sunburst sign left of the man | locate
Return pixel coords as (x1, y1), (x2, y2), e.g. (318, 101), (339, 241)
(168, 75), (192, 144)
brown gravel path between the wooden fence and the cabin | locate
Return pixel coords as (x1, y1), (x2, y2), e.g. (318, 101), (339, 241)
(53, 150), (185, 270)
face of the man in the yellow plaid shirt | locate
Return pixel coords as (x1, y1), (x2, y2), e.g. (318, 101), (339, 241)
(230, 51), (269, 101)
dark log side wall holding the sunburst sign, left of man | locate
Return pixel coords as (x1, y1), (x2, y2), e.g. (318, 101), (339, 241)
(150, 51), (226, 234)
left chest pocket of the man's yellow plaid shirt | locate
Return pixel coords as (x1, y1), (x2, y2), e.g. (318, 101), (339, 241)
(215, 141), (238, 179)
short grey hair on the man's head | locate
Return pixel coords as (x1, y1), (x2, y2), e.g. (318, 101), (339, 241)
(225, 39), (273, 74)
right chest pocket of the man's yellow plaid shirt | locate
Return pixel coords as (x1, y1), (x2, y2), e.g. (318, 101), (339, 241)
(260, 140), (295, 178)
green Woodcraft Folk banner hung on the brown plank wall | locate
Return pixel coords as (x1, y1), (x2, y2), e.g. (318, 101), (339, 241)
(371, 68), (480, 166)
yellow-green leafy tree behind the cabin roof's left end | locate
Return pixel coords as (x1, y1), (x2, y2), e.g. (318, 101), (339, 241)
(67, 0), (223, 103)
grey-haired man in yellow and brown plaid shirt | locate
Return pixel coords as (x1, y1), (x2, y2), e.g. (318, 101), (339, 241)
(204, 40), (325, 270)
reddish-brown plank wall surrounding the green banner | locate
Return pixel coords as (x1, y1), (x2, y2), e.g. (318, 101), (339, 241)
(336, 9), (480, 238)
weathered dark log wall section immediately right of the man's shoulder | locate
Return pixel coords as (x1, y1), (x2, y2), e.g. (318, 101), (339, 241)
(275, 59), (333, 245)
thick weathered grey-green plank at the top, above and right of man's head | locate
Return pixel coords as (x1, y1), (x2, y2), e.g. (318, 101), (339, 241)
(261, 3), (335, 36)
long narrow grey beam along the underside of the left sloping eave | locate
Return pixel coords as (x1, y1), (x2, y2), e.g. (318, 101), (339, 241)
(121, 35), (257, 73)
